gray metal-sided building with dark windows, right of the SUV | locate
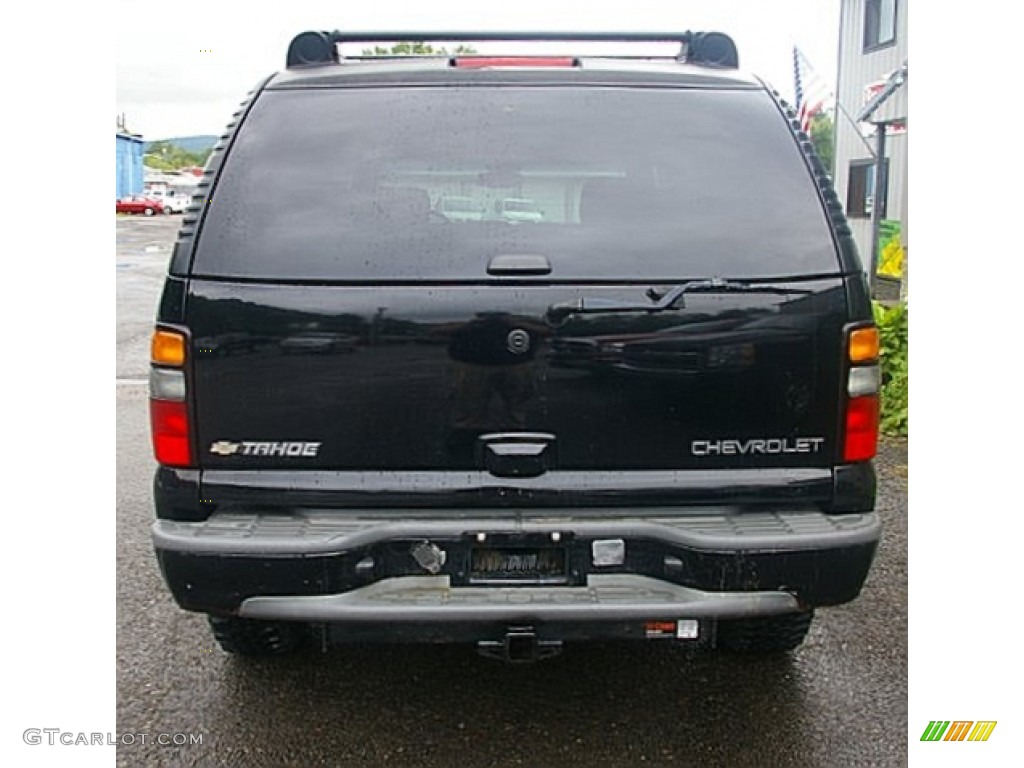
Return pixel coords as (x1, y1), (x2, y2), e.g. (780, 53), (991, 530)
(834, 0), (908, 299)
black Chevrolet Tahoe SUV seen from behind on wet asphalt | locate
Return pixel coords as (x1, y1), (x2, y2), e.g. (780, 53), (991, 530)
(152, 32), (881, 660)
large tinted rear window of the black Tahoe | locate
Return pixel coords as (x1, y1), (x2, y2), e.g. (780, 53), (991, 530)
(193, 87), (839, 282)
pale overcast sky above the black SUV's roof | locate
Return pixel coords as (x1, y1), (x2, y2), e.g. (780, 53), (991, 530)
(115, 0), (840, 140)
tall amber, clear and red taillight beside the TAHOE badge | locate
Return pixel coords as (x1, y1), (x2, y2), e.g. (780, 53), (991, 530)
(150, 329), (193, 467)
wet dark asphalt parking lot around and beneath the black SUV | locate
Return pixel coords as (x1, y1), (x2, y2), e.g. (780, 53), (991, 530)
(116, 216), (907, 766)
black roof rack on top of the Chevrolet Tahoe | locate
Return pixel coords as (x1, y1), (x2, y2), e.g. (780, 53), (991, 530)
(288, 31), (739, 69)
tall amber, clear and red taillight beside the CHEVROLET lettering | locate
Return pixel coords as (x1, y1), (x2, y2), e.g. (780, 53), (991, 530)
(843, 326), (882, 462)
